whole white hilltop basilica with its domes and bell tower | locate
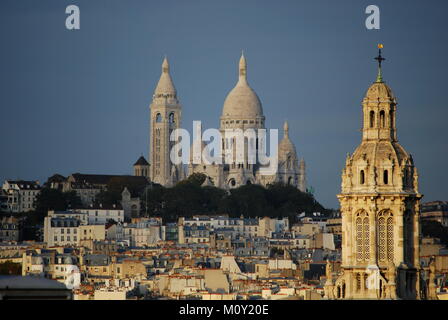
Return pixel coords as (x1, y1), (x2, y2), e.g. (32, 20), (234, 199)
(134, 54), (306, 192)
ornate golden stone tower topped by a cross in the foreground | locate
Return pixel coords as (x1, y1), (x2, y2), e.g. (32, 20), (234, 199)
(325, 45), (422, 299)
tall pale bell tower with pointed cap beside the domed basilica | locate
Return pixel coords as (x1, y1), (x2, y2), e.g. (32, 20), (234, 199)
(149, 57), (183, 186)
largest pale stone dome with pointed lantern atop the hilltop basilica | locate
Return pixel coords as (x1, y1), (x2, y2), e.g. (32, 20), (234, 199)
(222, 55), (263, 119)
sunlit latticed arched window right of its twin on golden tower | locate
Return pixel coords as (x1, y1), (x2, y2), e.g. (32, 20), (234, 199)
(378, 210), (394, 261)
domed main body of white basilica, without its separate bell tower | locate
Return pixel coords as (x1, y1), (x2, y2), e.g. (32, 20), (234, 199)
(188, 55), (306, 192)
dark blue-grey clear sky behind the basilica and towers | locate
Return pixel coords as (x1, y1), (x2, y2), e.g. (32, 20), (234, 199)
(0, 0), (448, 208)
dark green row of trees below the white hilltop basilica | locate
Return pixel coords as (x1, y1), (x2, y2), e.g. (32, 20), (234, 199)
(141, 174), (327, 221)
